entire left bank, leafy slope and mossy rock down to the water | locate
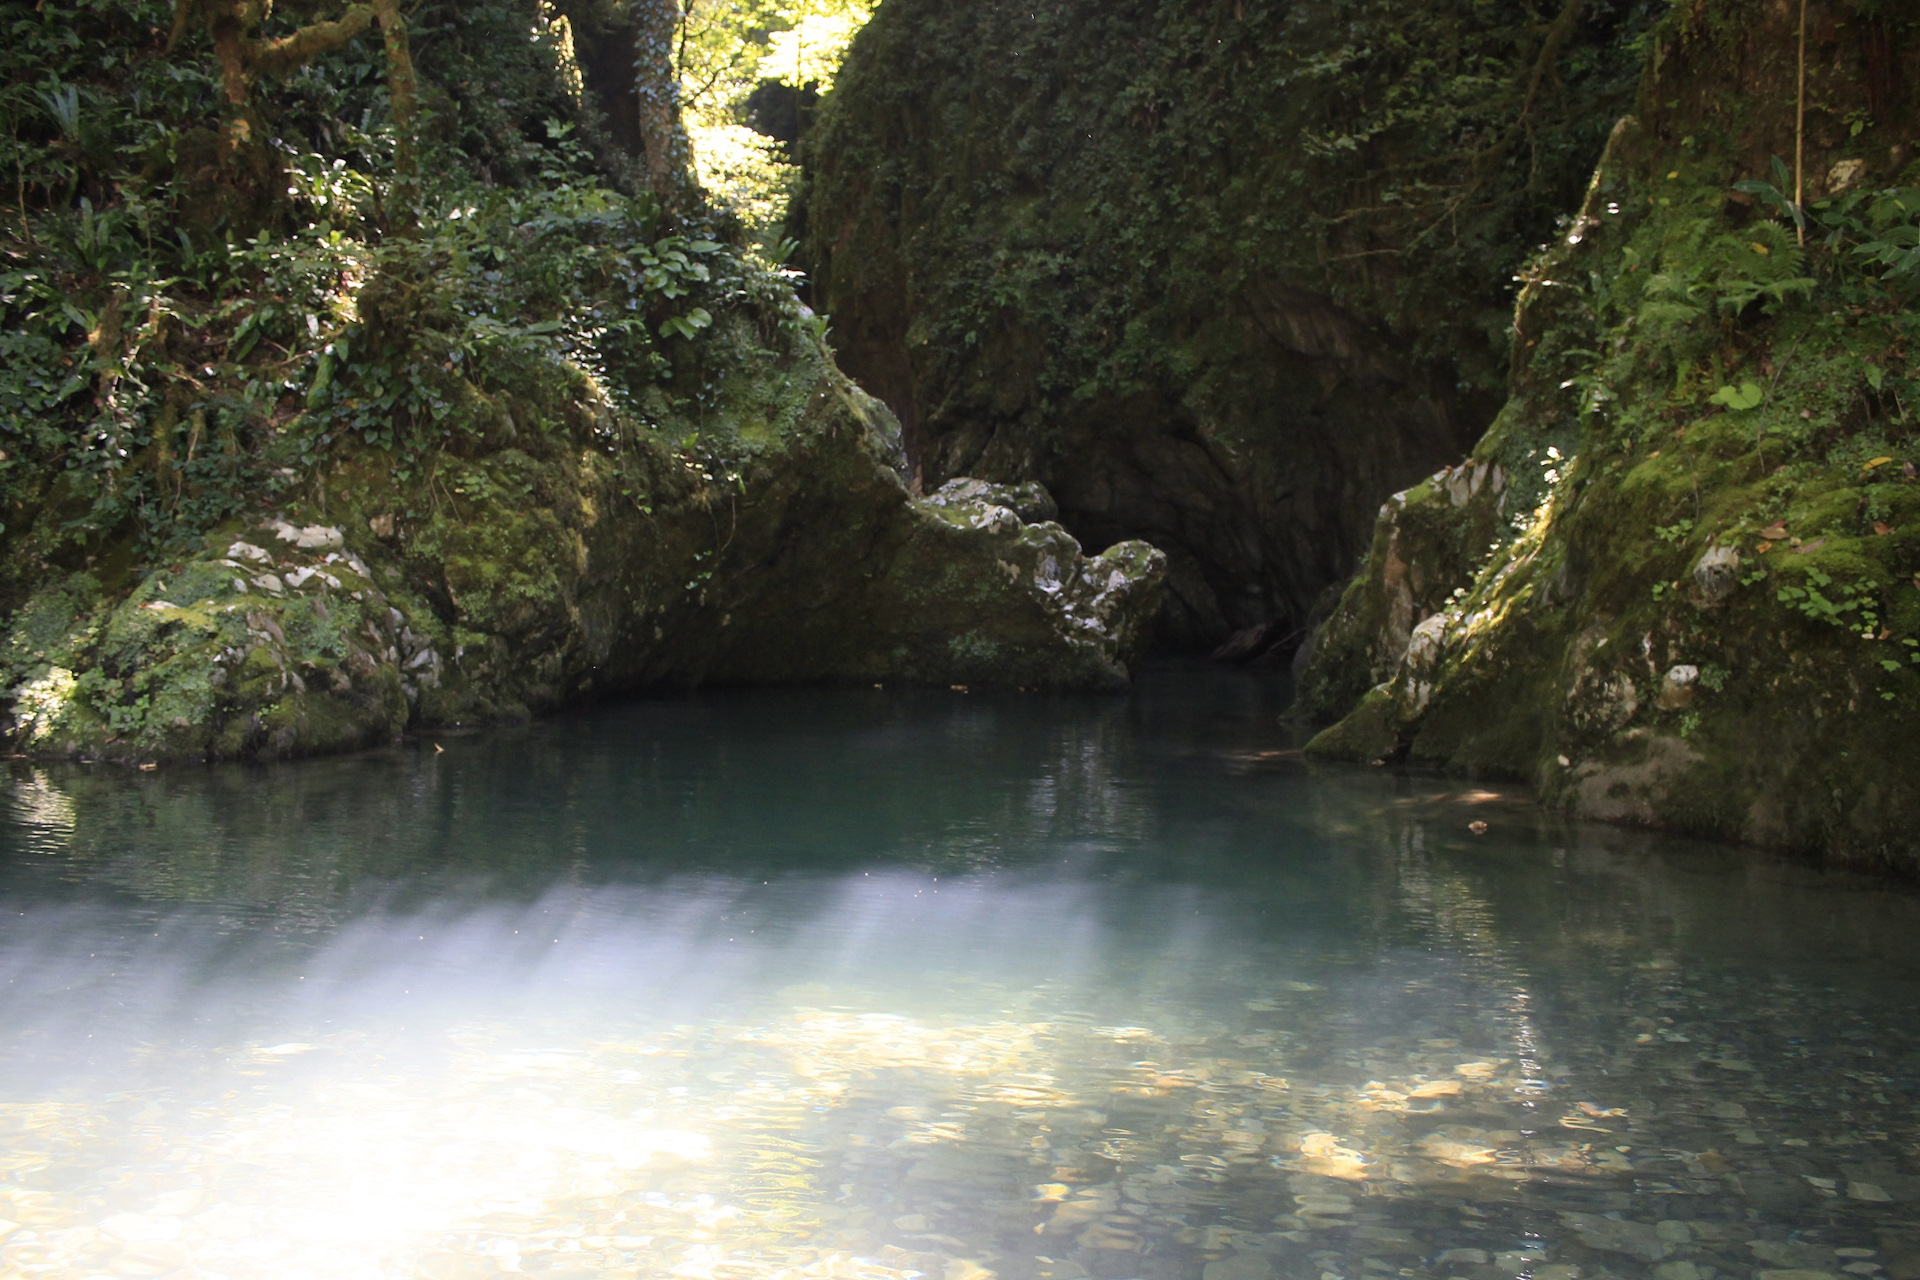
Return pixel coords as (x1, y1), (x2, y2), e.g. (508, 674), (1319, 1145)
(0, 0), (1165, 764)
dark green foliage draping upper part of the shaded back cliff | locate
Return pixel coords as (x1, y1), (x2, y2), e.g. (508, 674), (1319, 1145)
(808, 0), (1657, 413)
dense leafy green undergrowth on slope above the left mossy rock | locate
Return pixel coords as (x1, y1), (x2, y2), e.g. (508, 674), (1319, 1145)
(0, 0), (817, 583)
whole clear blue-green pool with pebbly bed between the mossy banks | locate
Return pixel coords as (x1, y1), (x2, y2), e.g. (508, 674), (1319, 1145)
(0, 670), (1920, 1280)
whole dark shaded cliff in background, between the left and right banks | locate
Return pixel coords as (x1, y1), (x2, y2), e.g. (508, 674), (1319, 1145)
(795, 0), (1659, 649)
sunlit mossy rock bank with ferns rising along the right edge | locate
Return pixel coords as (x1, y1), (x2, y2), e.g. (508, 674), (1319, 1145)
(1300, 0), (1920, 871)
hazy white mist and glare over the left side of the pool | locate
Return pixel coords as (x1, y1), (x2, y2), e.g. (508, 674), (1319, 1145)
(0, 869), (1282, 1276)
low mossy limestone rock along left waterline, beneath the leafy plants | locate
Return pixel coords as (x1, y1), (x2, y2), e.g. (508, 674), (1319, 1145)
(0, 335), (1165, 762)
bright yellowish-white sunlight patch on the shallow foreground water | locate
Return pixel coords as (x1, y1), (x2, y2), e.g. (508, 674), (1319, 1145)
(0, 948), (1589, 1280)
